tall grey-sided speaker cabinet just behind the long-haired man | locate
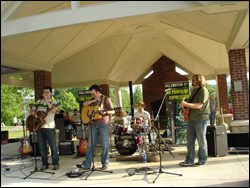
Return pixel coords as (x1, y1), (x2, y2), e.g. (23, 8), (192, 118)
(206, 125), (228, 157)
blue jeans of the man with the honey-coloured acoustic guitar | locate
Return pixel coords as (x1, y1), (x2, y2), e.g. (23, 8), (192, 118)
(83, 124), (109, 168)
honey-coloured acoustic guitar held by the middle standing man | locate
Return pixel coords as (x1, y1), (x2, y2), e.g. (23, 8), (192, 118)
(81, 106), (122, 124)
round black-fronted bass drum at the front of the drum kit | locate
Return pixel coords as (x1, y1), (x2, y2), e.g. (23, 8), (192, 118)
(115, 133), (138, 155)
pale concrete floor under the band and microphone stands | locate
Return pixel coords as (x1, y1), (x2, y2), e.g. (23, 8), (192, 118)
(1, 143), (249, 187)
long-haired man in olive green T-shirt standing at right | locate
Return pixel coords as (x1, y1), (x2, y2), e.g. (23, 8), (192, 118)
(179, 74), (209, 166)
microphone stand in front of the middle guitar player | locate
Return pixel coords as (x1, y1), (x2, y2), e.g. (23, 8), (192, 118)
(85, 97), (113, 180)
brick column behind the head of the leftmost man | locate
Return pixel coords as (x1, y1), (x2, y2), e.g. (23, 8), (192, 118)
(34, 70), (51, 100)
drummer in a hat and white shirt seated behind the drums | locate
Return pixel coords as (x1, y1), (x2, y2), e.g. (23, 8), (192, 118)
(132, 101), (153, 148)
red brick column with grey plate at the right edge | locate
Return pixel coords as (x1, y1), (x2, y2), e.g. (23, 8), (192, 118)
(228, 49), (249, 120)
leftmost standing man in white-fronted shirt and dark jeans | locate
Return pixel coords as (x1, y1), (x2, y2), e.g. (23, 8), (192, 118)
(31, 86), (59, 170)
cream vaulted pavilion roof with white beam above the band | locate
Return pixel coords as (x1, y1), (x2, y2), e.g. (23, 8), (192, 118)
(1, 1), (249, 88)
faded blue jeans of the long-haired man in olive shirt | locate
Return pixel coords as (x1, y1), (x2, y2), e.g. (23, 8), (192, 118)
(186, 120), (208, 164)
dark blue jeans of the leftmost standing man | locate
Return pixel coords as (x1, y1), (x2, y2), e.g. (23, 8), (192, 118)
(37, 128), (59, 165)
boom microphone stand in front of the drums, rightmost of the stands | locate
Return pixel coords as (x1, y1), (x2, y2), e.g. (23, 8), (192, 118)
(148, 90), (182, 183)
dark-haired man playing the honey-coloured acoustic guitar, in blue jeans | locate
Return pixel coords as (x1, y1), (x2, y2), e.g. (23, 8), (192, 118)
(76, 85), (115, 170)
